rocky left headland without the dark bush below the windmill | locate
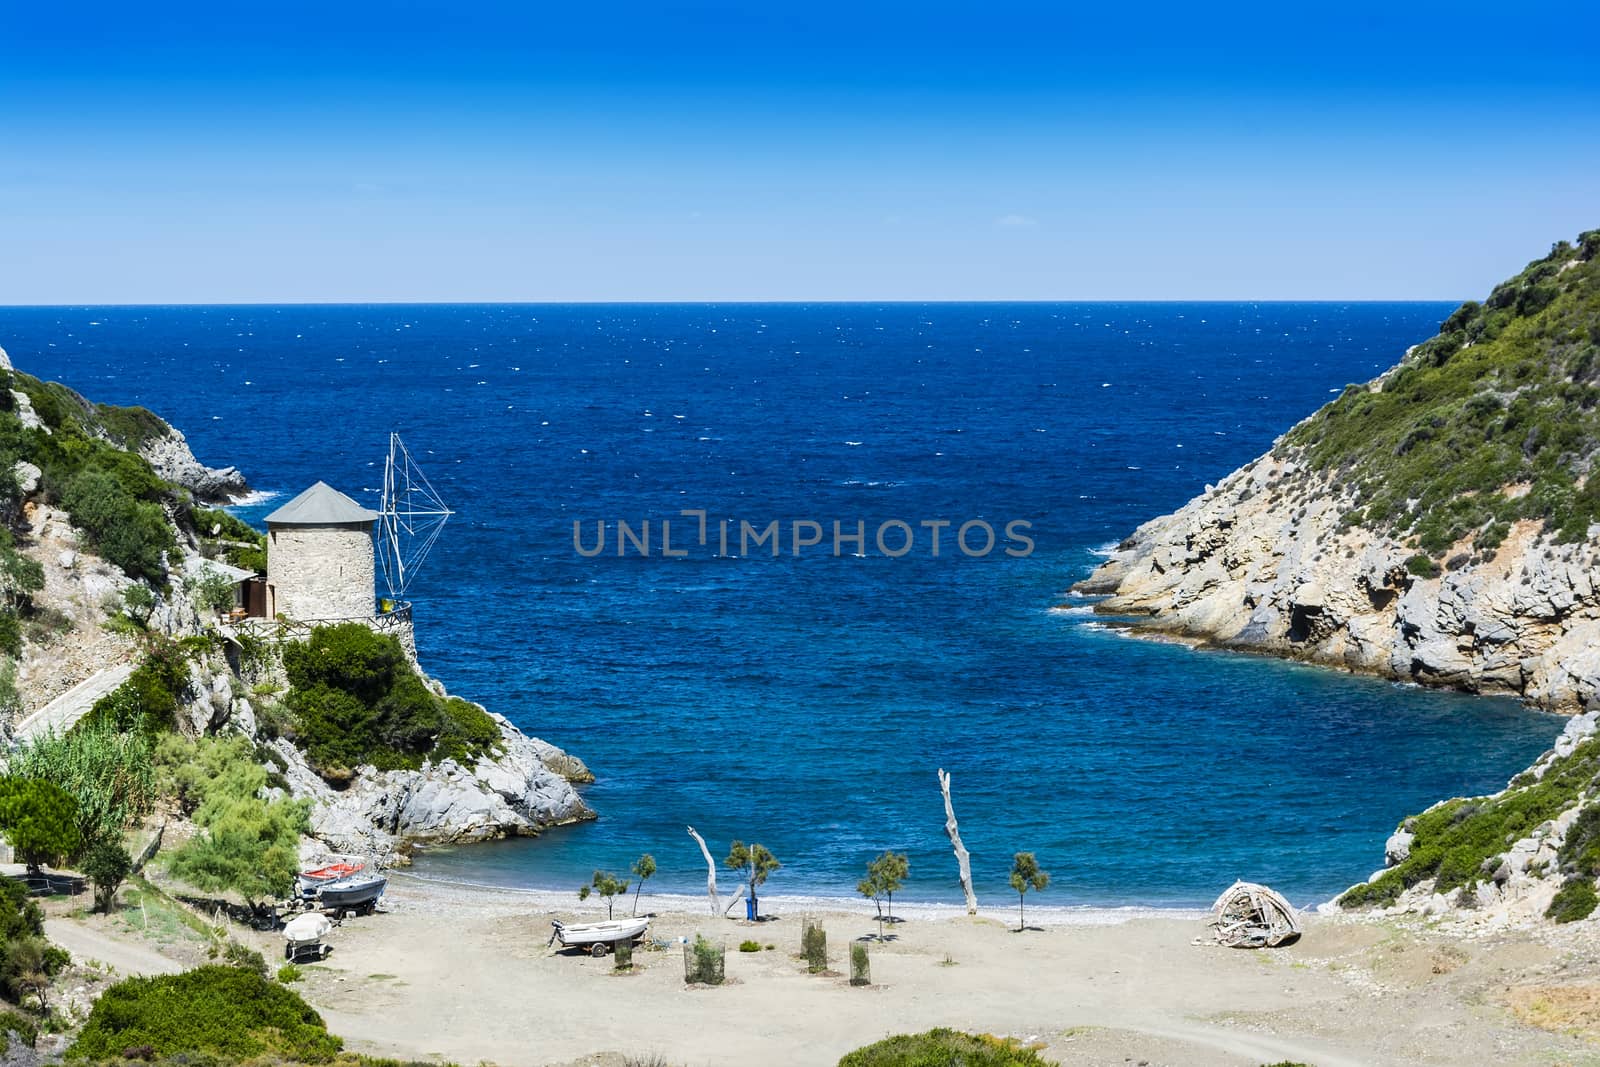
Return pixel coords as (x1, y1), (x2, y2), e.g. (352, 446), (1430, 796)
(0, 350), (594, 864)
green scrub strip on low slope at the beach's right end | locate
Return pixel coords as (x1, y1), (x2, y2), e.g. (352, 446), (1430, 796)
(1339, 739), (1600, 909)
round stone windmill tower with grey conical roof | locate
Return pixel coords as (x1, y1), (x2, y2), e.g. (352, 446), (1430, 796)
(266, 482), (379, 622)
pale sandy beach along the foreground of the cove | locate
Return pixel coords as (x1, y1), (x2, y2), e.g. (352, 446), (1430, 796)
(34, 872), (1600, 1067)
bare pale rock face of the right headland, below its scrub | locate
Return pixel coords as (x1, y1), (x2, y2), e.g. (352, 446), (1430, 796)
(1074, 442), (1600, 712)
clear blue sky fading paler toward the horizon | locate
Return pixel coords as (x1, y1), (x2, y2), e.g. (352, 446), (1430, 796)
(0, 0), (1600, 304)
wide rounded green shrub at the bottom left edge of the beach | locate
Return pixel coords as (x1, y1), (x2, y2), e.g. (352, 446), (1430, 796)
(67, 965), (342, 1064)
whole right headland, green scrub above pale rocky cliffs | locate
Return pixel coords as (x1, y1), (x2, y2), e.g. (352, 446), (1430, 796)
(1077, 230), (1600, 710)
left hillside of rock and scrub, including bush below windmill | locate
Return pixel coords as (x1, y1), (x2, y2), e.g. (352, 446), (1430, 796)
(0, 350), (594, 859)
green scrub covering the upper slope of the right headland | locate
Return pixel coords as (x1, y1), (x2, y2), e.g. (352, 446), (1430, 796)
(1286, 230), (1600, 559)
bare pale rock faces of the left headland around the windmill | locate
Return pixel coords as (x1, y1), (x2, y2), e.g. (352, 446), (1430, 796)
(0, 349), (595, 864)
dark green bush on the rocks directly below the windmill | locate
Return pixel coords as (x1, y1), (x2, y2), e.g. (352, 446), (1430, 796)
(283, 622), (501, 781)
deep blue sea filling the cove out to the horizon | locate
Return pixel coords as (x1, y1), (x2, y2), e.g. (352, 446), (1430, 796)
(0, 304), (1560, 905)
